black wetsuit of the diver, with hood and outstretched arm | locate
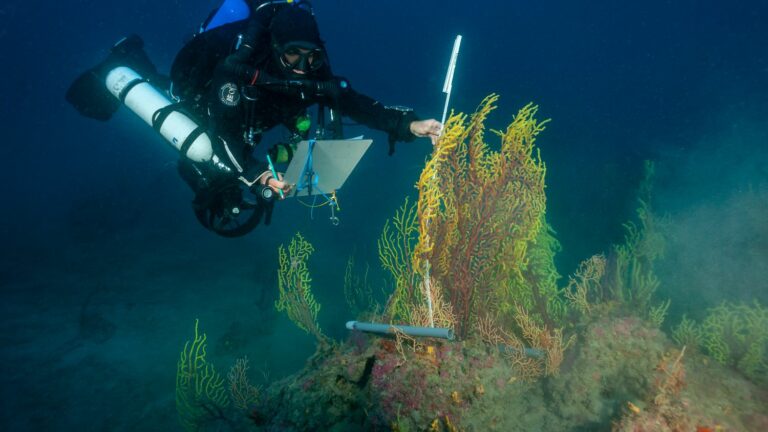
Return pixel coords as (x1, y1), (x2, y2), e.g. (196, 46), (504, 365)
(171, 0), (418, 235)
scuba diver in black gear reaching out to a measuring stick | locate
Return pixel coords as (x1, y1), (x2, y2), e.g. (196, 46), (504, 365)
(66, 0), (442, 237)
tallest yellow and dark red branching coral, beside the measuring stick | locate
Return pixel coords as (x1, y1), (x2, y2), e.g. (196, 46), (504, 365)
(413, 95), (547, 337)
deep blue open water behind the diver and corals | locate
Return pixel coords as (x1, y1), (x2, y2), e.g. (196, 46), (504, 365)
(0, 0), (768, 431)
